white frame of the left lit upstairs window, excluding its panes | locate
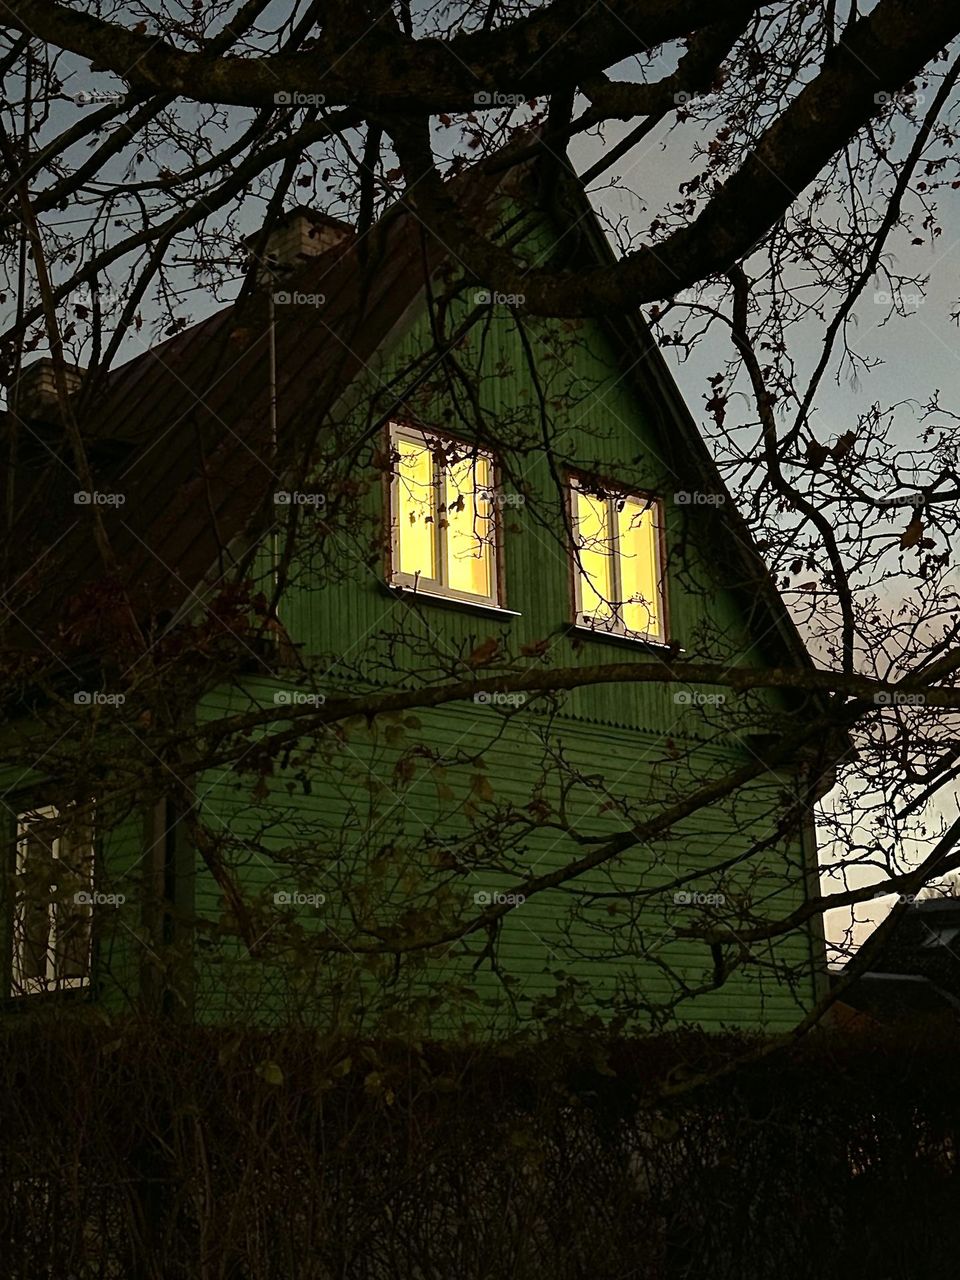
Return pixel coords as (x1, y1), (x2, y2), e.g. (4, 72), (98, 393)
(389, 422), (503, 609)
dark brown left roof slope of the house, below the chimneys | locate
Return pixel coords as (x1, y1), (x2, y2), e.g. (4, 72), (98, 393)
(6, 186), (445, 648)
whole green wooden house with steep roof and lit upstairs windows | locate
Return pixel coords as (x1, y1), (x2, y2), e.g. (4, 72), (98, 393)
(0, 160), (829, 1034)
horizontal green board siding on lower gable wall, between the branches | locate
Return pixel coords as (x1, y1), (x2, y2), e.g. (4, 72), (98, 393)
(198, 689), (813, 1032)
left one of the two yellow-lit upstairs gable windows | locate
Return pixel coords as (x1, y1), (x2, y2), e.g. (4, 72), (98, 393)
(390, 426), (498, 604)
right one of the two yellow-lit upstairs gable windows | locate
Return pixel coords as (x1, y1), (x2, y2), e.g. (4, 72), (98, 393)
(571, 480), (667, 640)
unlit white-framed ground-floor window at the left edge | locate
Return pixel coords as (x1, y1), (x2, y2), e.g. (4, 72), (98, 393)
(12, 805), (93, 996)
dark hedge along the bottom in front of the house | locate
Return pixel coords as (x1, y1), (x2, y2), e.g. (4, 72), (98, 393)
(0, 1024), (960, 1280)
